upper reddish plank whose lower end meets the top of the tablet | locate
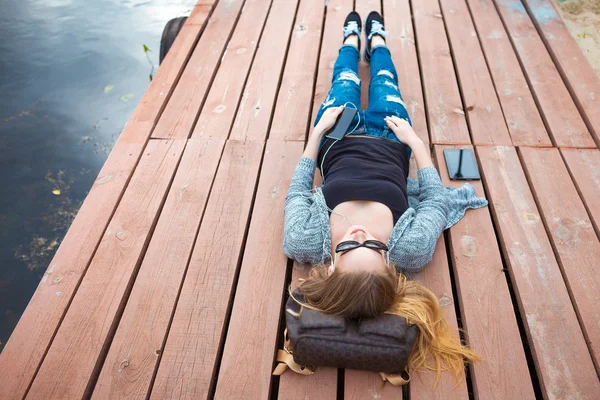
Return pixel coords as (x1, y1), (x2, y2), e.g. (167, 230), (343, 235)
(412, 0), (471, 144)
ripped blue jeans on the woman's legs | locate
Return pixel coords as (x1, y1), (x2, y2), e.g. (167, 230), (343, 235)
(314, 45), (412, 156)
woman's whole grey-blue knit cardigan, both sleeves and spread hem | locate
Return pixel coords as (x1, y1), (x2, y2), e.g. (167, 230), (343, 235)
(283, 157), (488, 274)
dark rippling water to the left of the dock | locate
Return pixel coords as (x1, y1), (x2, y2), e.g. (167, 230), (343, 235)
(0, 0), (196, 351)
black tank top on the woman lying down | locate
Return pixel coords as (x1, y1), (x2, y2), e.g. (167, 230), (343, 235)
(317, 136), (409, 224)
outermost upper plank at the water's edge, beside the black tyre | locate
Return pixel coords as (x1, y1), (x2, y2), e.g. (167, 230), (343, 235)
(131, 0), (215, 123)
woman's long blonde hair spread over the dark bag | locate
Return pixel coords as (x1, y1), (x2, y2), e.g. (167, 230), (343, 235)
(289, 265), (480, 388)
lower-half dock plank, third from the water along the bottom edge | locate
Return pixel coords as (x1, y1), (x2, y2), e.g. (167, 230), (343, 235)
(93, 139), (225, 399)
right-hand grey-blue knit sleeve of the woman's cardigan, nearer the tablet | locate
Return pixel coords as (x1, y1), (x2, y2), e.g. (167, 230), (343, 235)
(390, 167), (448, 273)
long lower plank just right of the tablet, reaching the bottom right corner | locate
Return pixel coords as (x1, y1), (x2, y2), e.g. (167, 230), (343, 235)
(477, 146), (600, 399)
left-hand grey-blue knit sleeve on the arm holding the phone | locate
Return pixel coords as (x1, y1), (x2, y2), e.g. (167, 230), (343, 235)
(283, 157), (325, 265)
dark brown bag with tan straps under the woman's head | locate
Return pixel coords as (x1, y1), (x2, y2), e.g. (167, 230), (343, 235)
(274, 289), (418, 384)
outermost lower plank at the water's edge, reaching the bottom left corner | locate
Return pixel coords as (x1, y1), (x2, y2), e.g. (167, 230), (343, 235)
(0, 122), (152, 399)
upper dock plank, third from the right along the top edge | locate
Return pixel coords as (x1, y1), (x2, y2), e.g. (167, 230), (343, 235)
(467, 0), (552, 146)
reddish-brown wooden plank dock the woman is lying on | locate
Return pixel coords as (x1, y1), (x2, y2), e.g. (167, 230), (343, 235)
(0, 0), (600, 400)
